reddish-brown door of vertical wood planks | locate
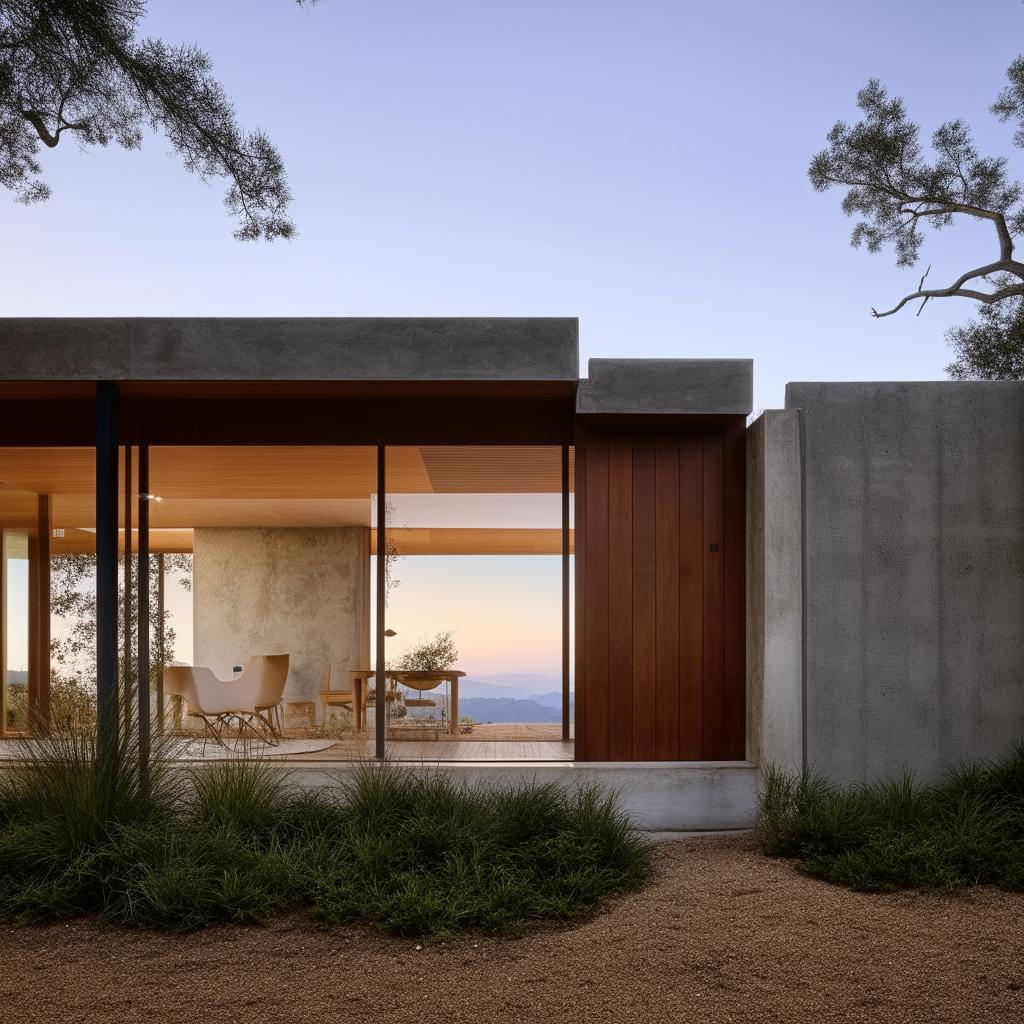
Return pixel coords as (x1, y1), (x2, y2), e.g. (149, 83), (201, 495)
(575, 417), (745, 761)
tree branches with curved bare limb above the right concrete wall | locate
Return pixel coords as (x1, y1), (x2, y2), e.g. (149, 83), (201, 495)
(808, 57), (1024, 379)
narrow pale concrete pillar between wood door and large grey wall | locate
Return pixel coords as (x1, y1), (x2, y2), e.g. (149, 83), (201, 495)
(746, 410), (804, 771)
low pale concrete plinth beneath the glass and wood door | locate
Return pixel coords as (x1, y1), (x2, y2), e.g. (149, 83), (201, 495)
(282, 761), (758, 831)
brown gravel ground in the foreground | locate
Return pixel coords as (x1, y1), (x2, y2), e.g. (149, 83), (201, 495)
(0, 839), (1024, 1024)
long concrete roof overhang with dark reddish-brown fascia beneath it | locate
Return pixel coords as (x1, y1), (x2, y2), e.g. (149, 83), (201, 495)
(0, 316), (579, 445)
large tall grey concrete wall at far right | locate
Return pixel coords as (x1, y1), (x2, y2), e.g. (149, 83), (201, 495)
(786, 382), (1024, 780)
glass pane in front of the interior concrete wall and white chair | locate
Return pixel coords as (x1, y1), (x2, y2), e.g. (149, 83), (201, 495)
(148, 445), (377, 741)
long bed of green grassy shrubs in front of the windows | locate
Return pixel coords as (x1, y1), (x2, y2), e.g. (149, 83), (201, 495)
(0, 735), (651, 936)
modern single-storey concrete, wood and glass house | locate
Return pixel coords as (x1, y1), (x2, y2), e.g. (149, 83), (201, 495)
(0, 317), (1024, 828)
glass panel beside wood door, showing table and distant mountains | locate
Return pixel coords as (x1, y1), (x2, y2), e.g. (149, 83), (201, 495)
(375, 445), (571, 760)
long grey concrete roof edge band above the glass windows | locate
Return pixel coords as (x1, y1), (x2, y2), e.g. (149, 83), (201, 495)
(0, 316), (579, 381)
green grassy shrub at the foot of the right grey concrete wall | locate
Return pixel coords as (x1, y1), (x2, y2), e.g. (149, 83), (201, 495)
(755, 743), (1024, 892)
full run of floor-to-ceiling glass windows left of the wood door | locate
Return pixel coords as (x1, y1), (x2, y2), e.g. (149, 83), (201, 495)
(0, 445), (571, 759)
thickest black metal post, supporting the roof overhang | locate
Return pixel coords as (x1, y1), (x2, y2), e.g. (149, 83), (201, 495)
(96, 381), (120, 758)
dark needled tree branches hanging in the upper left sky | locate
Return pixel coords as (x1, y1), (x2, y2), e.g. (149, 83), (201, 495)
(0, 0), (303, 240)
